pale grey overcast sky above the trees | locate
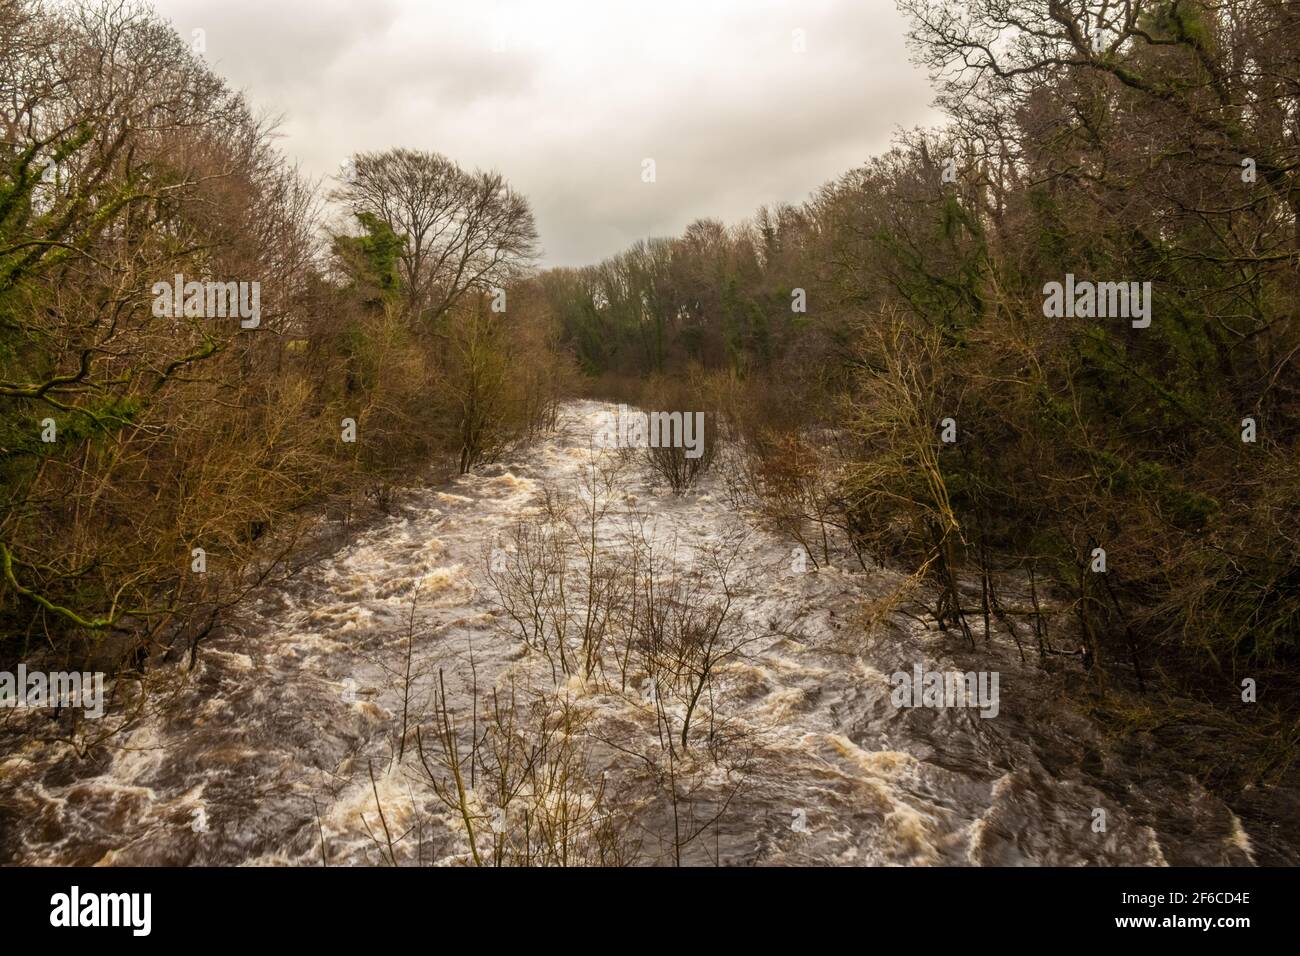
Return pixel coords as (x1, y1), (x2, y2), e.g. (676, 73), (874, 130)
(155, 0), (940, 265)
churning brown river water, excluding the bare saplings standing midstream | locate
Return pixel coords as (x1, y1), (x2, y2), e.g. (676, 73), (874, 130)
(0, 402), (1256, 865)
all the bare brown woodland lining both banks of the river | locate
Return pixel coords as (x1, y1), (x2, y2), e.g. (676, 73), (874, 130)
(0, 0), (1300, 777)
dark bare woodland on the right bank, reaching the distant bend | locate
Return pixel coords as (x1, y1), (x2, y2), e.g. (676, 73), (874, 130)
(540, 0), (1300, 697)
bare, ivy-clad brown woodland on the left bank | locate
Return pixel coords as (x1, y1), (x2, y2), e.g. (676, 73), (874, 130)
(0, 0), (571, 670)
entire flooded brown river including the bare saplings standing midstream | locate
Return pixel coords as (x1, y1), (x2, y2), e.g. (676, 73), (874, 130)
(0, 402), (1278, 865)
